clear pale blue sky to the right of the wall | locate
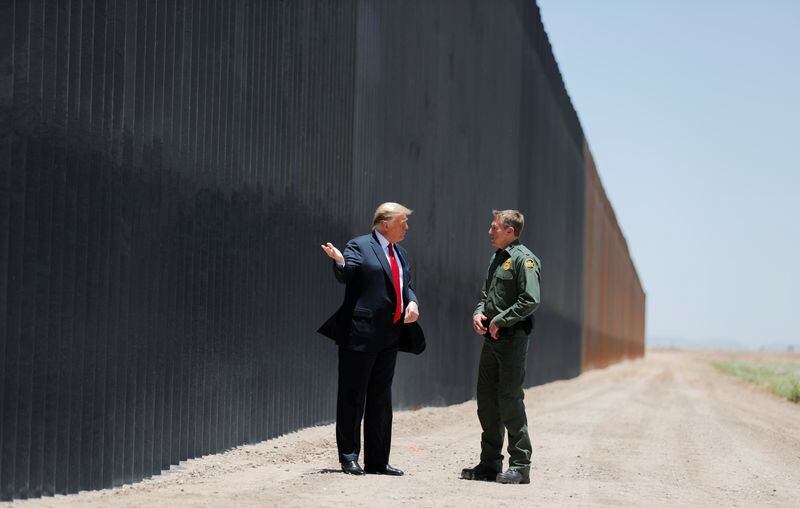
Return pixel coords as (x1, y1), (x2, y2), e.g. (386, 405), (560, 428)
(538, 0), (800, 347)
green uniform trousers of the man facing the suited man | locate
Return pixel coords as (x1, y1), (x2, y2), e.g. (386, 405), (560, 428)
(477, 335), (532, 478)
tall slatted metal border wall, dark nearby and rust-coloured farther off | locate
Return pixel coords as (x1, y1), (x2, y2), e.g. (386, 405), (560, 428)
(0, 0), (644, 500)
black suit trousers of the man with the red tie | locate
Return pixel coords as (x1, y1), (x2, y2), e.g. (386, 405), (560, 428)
(336, 347), (397, 468)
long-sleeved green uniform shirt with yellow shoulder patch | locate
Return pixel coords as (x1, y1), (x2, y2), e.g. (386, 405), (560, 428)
(473, 240), (542, 328)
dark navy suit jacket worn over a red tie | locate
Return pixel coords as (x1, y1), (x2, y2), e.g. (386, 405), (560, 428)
(318, 233), (425, 354)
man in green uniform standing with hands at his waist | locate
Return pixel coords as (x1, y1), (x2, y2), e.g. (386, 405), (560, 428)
(461, 210), (541, 483)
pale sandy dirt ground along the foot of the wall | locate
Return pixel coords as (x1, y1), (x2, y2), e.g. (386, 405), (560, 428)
(7, 350), (800, 507)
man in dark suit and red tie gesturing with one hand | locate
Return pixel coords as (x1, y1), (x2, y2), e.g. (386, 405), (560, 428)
(319, 203), (421, 476)
